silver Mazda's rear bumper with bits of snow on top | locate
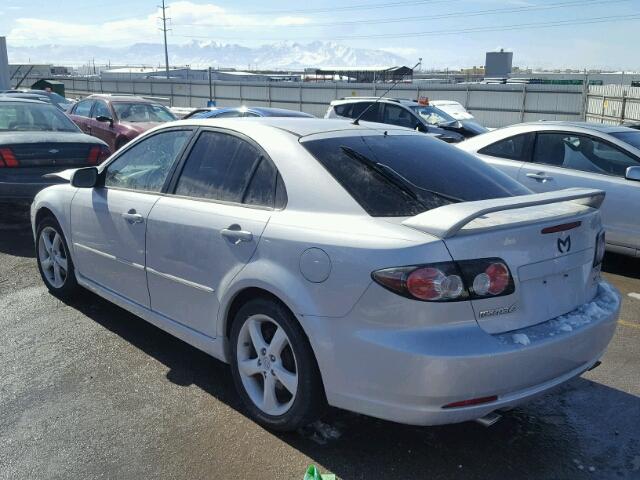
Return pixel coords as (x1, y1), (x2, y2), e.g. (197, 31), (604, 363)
(304, 282), (620, 425)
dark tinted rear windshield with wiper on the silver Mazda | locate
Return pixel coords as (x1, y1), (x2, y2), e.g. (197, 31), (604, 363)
(302, 135), (531, 217)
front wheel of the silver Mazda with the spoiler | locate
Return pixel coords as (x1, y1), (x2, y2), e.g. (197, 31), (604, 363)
(36, 216), (79, 298)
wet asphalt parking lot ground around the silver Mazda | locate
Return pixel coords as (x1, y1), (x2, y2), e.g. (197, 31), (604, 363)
(0, 206), (640, 480)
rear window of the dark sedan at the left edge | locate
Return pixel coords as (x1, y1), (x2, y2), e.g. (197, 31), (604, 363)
(0, 102), (80, 132)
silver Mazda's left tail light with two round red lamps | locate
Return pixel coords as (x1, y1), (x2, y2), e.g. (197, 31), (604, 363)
(371, 258), (515, 302)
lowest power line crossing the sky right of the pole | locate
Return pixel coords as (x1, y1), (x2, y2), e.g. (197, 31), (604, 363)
(175, 12), (640, 41)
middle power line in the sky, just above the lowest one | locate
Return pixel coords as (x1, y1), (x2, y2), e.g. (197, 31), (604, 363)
(175, 0), (632, 28)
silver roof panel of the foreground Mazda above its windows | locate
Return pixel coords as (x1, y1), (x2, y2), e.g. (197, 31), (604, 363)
(172, 117), (408, 137)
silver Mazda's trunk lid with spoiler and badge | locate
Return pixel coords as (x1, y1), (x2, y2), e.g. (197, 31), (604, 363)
(403, 189), (604, 333)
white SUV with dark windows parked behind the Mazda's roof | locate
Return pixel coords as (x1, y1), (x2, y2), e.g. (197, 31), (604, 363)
(324, 97), (487, 143)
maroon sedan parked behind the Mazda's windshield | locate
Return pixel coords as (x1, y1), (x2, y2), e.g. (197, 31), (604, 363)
(68, 95), (177, 152)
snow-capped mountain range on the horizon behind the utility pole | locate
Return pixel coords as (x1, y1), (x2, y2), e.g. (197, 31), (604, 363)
(9, 41), (411, 69)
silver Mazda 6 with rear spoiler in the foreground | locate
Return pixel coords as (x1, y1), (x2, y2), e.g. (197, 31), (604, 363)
(31, 118), (620, 430)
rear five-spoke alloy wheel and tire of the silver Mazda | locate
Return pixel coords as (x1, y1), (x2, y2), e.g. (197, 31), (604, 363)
(230, 298), (326, 431)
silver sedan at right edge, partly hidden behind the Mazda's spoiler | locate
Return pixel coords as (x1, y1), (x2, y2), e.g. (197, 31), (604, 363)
(458, 122), (640, 256)
